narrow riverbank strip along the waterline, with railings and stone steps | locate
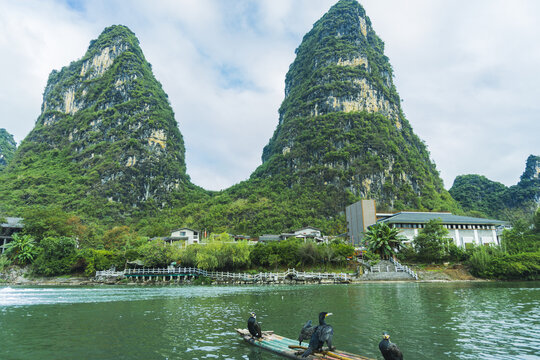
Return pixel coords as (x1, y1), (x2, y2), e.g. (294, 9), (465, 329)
(0, 265), (482, 286)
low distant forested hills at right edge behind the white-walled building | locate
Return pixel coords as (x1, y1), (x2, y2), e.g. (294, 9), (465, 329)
(449, 155), (540, 220)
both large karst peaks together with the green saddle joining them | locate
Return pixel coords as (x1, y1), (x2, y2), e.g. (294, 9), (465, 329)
(0, 0), (458, 235)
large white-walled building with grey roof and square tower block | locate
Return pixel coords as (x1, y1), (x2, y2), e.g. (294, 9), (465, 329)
(345, 200), (507, 248)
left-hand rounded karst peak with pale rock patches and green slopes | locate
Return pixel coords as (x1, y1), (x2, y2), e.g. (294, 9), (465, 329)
(0, 26), (206, 219)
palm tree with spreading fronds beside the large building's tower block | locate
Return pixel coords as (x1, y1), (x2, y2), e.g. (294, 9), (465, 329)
(364, 223), (404, 259)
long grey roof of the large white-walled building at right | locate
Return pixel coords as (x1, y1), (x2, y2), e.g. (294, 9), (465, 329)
(380, 212), (507, 225)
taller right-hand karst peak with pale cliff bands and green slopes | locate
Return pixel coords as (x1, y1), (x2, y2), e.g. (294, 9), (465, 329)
(253, 0), (456, 210)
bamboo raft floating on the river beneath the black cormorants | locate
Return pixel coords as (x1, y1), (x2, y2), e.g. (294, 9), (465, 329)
(236, 329), (374, 360)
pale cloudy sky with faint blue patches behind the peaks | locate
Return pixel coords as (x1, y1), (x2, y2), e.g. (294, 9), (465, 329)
(0, 0), (540, 190)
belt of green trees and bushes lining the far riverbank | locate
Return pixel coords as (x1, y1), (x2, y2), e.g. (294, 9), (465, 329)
(0, 210), (540, 280)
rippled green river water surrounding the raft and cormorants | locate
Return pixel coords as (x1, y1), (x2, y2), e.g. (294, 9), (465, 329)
(0, 282), (540, 360)
